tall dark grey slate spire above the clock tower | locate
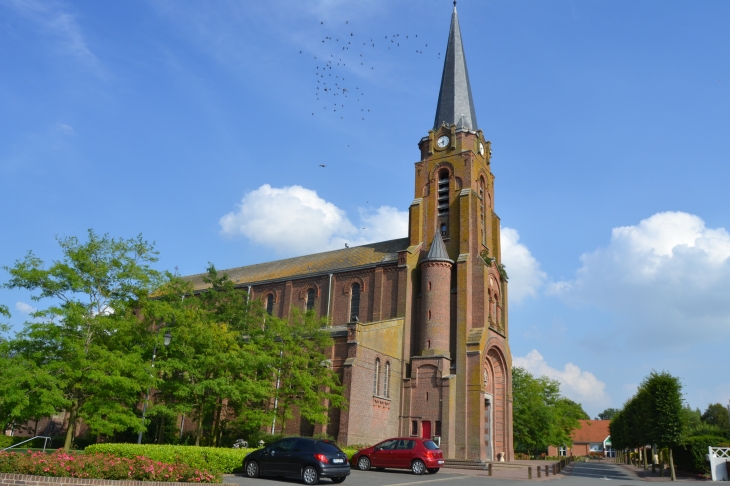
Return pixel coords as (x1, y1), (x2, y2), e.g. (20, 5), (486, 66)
(433, 6), (478, 130)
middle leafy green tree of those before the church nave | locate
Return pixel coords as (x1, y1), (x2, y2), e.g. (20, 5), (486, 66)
(145, 272), (273, 445)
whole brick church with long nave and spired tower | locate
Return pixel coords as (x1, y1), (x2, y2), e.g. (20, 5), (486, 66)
(189, 7), (514, 461)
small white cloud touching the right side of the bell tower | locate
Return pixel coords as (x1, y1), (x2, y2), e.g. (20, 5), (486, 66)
(501, 228), (547, 303)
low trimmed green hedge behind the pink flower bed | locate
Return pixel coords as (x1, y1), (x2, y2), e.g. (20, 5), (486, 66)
(84, 444), (255, 474)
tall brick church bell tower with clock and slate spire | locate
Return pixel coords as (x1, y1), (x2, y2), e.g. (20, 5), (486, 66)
(403, 6), (514, 461)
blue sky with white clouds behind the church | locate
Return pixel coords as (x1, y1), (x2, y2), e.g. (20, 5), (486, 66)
(0, 0), (730, 415)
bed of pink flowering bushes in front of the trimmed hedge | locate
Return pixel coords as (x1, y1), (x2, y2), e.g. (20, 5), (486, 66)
(0, 450), (221, 483)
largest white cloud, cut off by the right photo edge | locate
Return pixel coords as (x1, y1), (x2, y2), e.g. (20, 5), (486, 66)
(548, 212), (730, 346)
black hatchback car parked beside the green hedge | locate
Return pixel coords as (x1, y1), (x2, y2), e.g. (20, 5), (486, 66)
(243, 437), (350, 485)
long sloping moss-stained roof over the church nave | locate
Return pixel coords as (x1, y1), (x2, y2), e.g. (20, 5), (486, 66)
(184, 238), (409, 290)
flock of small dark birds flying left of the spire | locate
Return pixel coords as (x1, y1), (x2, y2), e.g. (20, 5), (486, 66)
(299, 20), (441, 129)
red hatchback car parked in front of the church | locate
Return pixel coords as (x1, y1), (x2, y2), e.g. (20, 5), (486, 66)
(351, 437), (444, 474)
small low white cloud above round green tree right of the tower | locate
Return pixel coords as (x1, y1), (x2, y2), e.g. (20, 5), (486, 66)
(512, 349), (611, 407)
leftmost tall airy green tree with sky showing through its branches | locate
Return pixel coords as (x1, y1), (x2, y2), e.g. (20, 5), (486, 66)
(3, 230), (159, 449)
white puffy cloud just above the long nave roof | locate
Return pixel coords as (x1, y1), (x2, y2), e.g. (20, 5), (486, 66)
(219, 184), (408, 255)
